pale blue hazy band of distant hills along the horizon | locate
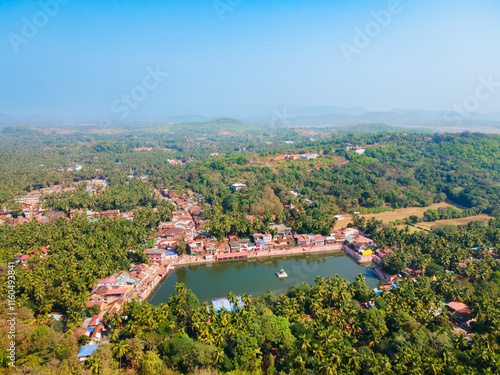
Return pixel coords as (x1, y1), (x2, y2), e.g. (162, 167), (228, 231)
(0, 105), (500, 133)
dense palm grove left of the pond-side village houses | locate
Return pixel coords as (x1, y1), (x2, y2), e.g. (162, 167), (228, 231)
(0, 206), (174, 326)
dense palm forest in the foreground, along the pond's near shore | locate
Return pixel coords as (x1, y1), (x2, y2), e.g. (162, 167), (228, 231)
(2, 221), (500, 374)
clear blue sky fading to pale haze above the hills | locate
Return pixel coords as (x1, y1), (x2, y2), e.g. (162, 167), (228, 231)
(0, 0), (500, 118)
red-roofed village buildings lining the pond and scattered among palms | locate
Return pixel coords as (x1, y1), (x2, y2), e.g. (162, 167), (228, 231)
(7, 185), (492, 360)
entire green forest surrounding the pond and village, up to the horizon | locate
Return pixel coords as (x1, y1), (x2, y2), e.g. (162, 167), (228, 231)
(0, 125), (500, 375)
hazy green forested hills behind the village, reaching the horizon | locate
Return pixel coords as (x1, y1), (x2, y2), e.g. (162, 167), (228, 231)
(0, 129), (500, 221)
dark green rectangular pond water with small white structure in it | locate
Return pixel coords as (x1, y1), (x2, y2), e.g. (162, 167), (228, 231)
(148, 253), (379, 305)
